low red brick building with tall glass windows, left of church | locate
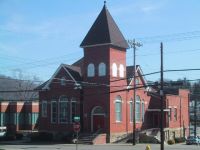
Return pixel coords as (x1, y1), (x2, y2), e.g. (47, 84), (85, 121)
(0, 101), (39, 133)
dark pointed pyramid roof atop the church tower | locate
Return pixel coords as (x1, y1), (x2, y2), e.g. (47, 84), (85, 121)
(80, 4), (128, 48)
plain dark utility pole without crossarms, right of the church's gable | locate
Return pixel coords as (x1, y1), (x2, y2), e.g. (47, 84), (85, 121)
(160, 42), (164, 150)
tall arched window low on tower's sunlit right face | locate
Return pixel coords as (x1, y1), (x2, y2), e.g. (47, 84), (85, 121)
(115, 96), (122, 122)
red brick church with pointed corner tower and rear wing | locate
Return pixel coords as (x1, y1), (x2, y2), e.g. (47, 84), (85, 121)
(38, 5), (189, 142)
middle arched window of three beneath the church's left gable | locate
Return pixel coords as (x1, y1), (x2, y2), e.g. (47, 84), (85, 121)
(59, 96), (69, 123)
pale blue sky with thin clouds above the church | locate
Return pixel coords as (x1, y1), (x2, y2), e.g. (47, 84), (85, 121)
(0, 0), (200, 81)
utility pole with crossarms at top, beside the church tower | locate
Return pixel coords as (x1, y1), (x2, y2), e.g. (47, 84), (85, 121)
(128, 39), (142, 145)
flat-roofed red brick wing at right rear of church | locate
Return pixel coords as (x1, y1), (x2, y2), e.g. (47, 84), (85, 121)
(147, 88), (190, 139)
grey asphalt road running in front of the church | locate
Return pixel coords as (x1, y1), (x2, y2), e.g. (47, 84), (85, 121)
(0, 144), (200, 150)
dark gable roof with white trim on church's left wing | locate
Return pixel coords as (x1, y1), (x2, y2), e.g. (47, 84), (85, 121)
(40, 64), (82, 90)
